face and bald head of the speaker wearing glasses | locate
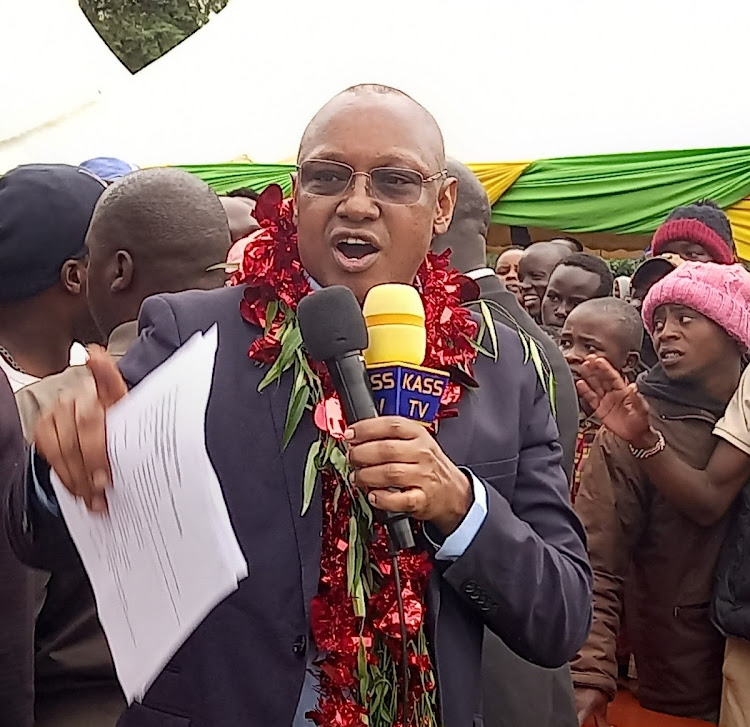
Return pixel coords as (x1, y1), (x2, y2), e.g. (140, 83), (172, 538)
(294, 94), (456, 302)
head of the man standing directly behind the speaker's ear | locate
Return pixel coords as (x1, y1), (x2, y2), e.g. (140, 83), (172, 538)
(432, 159), (492, 273)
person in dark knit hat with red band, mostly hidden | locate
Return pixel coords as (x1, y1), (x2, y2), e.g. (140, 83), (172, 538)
(651, 199), (736, 265)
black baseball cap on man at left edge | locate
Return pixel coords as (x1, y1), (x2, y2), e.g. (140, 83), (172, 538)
(0, 164), (105, 301)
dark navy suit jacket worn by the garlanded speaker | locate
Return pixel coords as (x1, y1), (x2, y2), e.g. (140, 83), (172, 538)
(4, 288), (591, 727)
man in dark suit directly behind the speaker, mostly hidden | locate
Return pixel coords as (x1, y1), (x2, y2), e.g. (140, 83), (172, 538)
(432, 159), (578, 727)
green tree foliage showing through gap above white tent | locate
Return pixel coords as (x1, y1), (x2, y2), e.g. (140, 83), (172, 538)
(78, 0), (229, 73)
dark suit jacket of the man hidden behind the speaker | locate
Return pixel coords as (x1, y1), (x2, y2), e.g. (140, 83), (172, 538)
(476, 275), (578, 727)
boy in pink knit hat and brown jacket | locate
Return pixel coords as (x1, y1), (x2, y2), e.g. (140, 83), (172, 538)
(572, 263), (750, 723)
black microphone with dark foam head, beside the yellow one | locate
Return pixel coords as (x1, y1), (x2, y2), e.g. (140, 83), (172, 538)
(297, 285), (421, 550)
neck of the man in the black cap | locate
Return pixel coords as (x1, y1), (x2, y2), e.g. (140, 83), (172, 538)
(0, 305), (73, 378)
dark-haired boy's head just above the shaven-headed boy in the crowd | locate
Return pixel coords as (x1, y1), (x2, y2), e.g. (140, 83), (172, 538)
(542, 252), (614, 338)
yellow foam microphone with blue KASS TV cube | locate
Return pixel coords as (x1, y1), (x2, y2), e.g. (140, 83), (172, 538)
(363, 283), (450, 424)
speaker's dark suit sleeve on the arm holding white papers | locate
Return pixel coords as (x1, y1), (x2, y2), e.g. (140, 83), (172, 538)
(5, 296), (181, 570)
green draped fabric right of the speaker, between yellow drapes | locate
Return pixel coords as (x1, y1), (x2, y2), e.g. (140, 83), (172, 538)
(492, 147), (750, 234)
